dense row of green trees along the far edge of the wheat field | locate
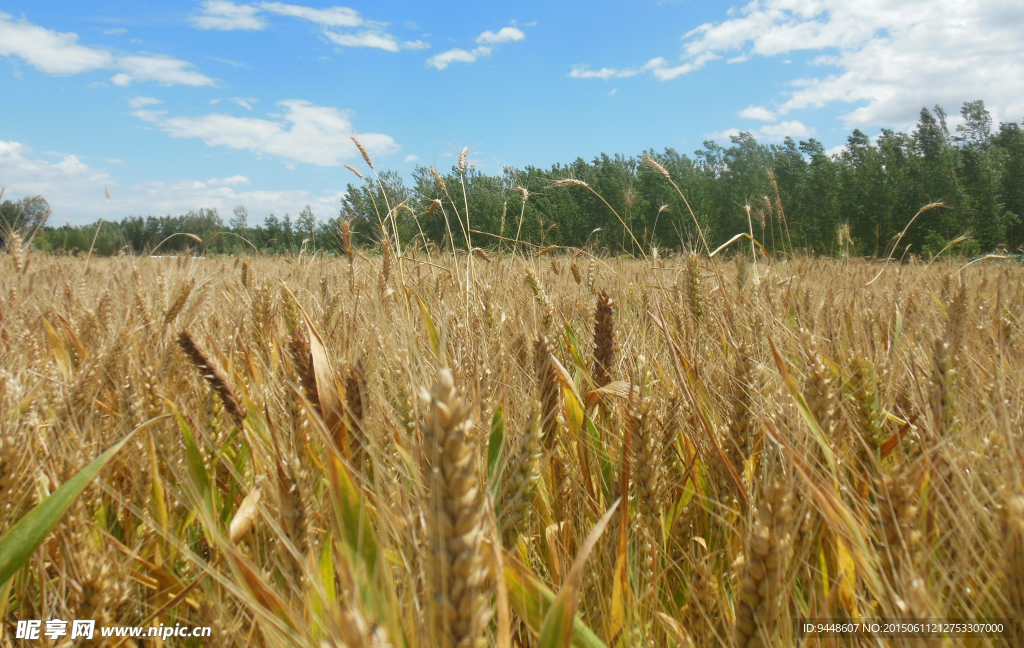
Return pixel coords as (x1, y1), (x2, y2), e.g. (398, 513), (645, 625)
(6, 100), (1024, 258)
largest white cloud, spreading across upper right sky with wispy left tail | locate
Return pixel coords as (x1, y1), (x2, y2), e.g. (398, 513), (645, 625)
(585, 0), (1024, 128)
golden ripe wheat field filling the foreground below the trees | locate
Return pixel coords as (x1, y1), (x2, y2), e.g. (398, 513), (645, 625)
(0, 246), (1024, 648)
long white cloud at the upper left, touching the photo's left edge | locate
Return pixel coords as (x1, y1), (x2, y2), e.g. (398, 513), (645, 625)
(0, 12), (216, 87)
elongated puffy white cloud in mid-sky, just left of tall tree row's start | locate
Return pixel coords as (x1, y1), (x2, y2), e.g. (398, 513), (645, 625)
(133, 99), (398, 166)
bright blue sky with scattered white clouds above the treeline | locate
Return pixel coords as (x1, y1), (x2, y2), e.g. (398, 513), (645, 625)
(0, 0), (1024, 224)
